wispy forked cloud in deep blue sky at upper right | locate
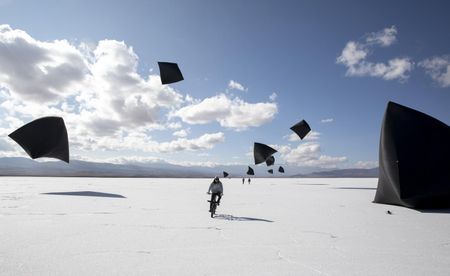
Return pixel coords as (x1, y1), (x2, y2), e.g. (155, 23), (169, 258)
(336, 26), (414, 81)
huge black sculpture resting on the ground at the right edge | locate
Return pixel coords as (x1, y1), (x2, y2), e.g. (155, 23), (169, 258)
(374, 102), (450, 208)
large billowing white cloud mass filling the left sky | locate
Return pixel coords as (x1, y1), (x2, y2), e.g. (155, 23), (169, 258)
(0, 25), (230, 153)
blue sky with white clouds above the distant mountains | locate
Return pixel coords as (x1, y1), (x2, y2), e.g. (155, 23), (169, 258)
(0, 0), (450, 168)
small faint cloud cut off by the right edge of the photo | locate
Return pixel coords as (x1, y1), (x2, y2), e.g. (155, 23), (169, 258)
(419, 56), (450, 87)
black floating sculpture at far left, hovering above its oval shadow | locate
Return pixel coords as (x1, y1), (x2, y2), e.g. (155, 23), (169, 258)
(8, 117), (69, 163)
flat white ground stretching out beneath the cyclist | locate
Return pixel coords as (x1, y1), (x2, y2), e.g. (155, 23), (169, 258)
(0, 177), (450, 275)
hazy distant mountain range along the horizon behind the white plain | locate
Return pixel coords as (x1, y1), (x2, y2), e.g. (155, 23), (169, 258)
(0, 157), (378, 178)
